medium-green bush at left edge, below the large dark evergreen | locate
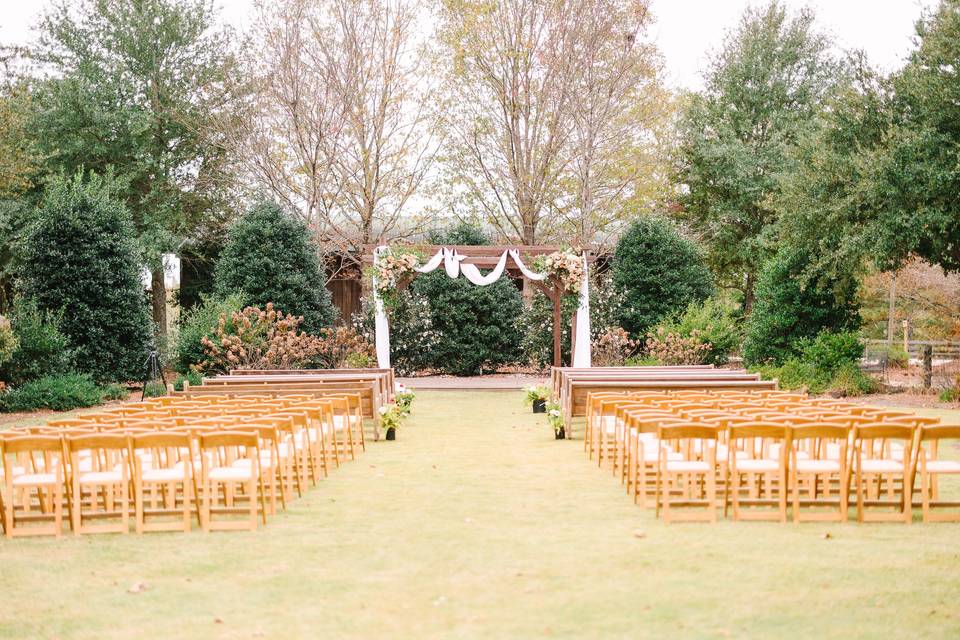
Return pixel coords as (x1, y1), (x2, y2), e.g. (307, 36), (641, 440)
(0, 298), (71, 387)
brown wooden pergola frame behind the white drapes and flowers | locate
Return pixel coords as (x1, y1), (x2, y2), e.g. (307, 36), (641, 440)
(363, 244), (597, 367)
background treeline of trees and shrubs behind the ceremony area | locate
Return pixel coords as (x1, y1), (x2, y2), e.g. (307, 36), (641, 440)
(0, 0), (960, 404)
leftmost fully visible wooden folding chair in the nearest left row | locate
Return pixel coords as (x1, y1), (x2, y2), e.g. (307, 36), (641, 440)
(0, 435), (69, 538)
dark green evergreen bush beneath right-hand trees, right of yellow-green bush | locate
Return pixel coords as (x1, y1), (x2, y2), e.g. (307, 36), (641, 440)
(743, 247), (860, 365)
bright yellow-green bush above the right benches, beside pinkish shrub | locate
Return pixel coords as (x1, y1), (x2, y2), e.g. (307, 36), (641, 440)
(653, 298), (741, 365)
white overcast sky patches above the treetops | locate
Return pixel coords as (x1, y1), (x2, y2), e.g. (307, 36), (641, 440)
(0, 0), (937, 89)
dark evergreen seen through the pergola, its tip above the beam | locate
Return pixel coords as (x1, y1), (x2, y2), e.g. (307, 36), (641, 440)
(411, 224), (523, 376)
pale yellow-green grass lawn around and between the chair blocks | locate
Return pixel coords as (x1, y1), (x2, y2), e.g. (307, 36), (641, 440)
(0, 391), (960, 638)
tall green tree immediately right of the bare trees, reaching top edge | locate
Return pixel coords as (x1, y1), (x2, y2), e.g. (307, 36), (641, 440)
(677, 0), (840, 314)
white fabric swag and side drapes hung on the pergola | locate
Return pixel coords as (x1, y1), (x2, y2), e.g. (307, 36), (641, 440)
(373, 246), (590, 369)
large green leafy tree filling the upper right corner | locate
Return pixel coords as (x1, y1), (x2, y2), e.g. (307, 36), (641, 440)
(776, 0), (960, 279)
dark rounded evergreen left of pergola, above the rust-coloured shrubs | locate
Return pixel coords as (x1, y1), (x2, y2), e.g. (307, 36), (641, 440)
(214, 202), (337, 333)
